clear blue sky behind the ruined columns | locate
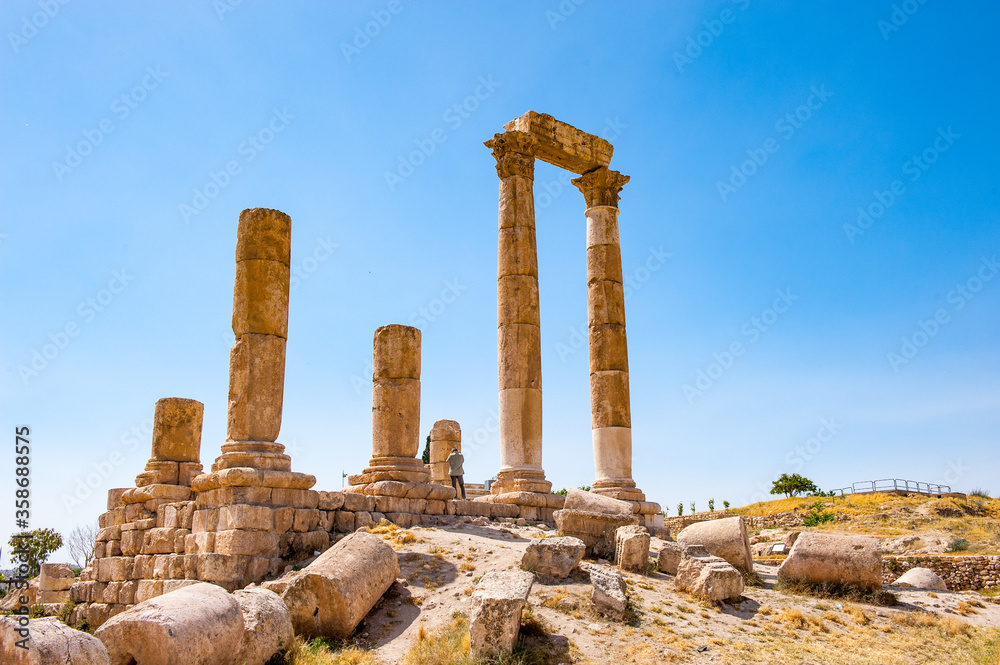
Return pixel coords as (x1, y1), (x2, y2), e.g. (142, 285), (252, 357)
(0, 0), (1000, 556)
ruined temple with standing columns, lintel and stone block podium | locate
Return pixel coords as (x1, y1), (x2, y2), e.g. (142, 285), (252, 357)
(70, 111), (663, 632)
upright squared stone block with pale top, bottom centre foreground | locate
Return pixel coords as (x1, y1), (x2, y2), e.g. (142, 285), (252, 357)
(469, 571), (535, 658)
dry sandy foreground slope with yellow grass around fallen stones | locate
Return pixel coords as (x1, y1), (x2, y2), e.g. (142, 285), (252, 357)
(342, 518), (1000, 665)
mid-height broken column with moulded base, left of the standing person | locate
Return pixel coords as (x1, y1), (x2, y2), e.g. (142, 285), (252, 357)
(351, 325), (430, 484)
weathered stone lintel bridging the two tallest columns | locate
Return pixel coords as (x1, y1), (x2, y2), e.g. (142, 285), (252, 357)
(503, 111), (615, 173)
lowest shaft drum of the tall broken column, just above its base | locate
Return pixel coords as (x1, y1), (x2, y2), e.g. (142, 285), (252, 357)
(226, 334), (285, 441)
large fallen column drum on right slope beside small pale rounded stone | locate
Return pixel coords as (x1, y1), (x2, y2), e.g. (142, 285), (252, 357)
(778, 532), (882, 589)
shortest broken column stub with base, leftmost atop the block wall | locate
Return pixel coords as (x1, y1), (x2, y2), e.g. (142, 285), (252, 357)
(135, 397), (205, 487)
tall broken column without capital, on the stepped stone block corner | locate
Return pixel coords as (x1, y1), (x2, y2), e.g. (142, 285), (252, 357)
(212, 208), (292, 471)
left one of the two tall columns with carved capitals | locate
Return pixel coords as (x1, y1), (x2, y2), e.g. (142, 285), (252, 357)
(485, 130), (552, 494)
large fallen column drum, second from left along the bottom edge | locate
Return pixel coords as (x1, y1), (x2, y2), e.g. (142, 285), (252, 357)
(94, 582), (243, 665)
